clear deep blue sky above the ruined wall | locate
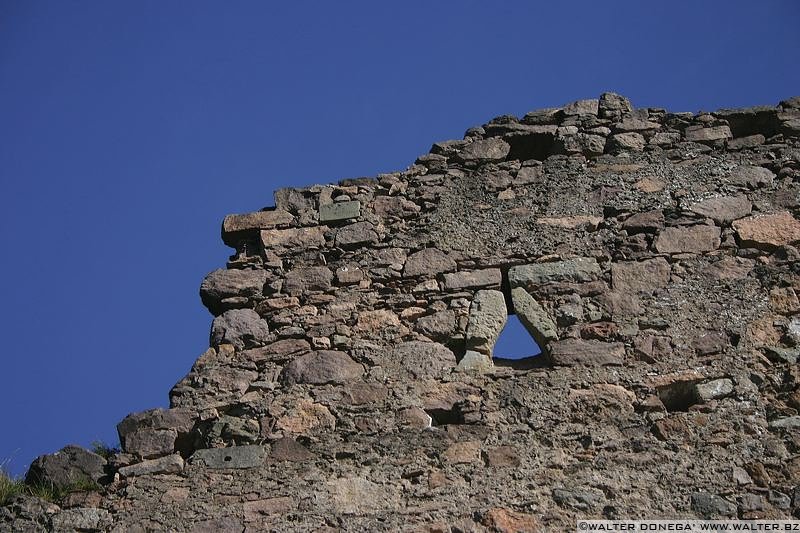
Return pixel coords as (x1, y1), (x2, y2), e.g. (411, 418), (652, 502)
(0, 0), (800, 474)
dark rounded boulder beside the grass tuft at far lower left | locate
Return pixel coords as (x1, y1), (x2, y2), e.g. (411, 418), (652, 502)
(25, 445), (106, 487)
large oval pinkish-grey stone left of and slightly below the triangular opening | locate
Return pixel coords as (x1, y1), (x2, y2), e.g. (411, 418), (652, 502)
(281, 350), (364, 385)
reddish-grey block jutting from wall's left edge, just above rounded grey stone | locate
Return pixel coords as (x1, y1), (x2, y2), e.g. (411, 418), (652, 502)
(200, 269), (267, 315)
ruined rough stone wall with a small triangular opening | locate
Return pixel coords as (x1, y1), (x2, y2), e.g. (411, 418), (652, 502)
(6, 93), (800, 532)
